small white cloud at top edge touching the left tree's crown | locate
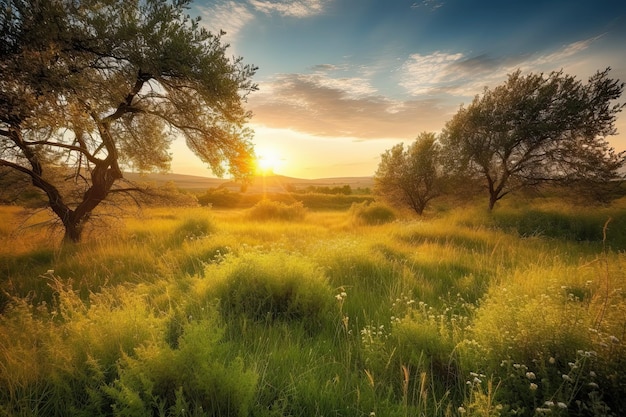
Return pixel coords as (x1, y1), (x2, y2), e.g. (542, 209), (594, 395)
(198, 0), (254, 39)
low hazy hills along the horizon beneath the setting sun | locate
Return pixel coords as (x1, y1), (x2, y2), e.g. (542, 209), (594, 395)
(124, 173), (374, 192)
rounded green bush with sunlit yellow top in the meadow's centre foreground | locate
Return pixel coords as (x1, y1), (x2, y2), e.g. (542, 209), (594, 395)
(206, 252), (333, 328)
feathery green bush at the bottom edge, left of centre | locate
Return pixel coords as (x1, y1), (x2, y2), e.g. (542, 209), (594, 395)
(106, 319), (258, 417)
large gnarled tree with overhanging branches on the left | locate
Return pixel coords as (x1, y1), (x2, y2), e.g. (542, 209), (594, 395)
(0, 0), (256, 242)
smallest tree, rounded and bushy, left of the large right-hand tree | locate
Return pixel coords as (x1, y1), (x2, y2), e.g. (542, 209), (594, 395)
(374, 132), (443, 216)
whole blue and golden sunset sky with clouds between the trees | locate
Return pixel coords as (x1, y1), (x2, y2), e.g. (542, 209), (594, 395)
(172, 0), (626, 179)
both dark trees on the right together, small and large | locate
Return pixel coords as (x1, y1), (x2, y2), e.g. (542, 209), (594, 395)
(374, 69), (626, 215)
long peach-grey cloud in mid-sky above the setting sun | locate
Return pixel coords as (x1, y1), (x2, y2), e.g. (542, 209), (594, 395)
(249, 74), (449, 140)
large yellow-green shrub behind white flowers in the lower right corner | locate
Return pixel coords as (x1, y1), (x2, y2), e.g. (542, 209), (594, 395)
(459, 271), (626, 416)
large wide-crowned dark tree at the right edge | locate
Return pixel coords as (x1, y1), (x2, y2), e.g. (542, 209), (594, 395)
(441, 69), (625, 210)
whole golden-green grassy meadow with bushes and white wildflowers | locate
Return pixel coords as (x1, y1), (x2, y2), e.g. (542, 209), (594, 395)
(0, 197), (626, 417)
